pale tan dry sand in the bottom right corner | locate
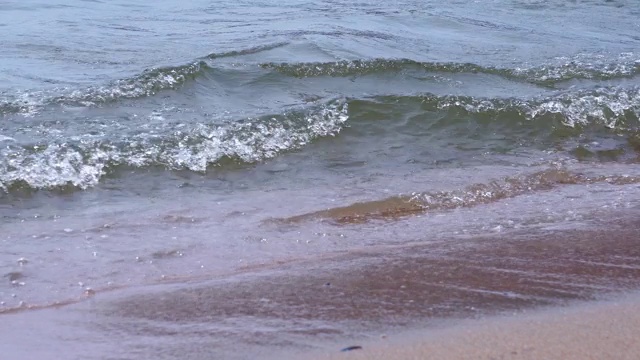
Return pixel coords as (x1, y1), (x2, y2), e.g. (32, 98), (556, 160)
(304, 294), (640, 360)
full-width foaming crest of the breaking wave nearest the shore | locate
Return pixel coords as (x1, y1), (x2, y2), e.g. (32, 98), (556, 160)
(0, 81), (640, 190)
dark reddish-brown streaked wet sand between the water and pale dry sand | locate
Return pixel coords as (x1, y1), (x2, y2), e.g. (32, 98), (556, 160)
(104, 220), (640, 358)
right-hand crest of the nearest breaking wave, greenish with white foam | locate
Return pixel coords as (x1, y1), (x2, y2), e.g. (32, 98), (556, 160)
(351, 87), (640, 131)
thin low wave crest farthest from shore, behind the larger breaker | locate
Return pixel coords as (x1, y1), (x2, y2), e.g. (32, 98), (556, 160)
(0, 50), (640, 115)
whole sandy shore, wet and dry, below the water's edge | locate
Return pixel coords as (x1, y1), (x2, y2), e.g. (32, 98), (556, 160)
(0, 212), (640, 359)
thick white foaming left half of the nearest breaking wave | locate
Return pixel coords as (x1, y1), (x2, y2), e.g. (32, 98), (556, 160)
(0, 100), (348, 191)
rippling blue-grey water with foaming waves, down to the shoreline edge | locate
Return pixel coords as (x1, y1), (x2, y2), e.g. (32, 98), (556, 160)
(0, 0), (640, 310)
